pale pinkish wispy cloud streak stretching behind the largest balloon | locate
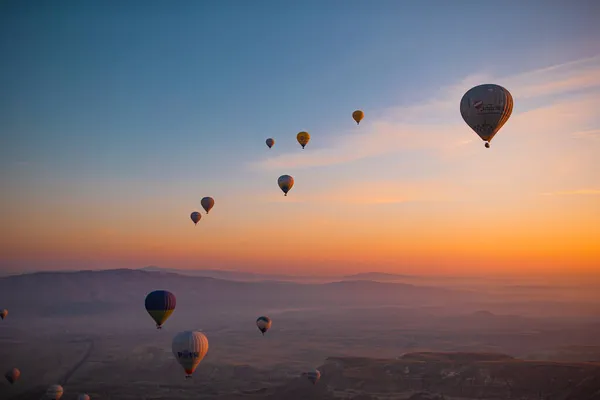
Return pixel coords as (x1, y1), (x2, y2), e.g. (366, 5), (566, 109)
(251, 56), (600, 170)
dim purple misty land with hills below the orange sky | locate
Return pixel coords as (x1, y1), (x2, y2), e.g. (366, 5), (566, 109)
(0, 271), (600, 400)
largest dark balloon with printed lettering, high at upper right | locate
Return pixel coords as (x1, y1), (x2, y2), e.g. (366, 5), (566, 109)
(460, 84), (513, 148)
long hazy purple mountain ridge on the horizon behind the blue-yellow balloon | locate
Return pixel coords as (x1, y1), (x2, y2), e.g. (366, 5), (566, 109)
(0, 269), (472, 316)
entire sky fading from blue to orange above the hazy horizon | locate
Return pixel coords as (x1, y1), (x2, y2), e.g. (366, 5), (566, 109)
(0, 0), (600, 274)
